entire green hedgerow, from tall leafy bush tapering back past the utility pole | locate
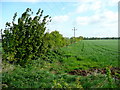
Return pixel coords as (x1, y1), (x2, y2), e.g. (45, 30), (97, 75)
(2, 8), (81, 65)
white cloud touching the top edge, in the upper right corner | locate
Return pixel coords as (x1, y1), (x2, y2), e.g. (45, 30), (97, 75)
(76, 0), (119, 13)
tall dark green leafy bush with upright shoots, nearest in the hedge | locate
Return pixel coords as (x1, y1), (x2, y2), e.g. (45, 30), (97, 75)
(2, 8), (51, 65)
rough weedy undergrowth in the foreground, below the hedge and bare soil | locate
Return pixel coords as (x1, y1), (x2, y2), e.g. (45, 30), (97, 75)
(2, 51), (118, 88)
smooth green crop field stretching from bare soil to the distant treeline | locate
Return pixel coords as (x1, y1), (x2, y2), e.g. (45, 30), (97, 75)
(62, 40), (119, 68)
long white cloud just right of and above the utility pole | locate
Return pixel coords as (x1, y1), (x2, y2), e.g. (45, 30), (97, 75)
(75, 10), (118, 26)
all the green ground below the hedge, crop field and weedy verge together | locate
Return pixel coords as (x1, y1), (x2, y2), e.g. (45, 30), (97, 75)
(2, 40), (120, 88)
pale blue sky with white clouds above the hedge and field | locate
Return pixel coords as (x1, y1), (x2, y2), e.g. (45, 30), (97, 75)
(0, 0), (119, 37)
